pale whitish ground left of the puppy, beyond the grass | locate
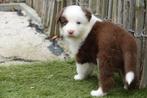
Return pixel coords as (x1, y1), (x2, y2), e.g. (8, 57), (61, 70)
(0, 11), (61, 64)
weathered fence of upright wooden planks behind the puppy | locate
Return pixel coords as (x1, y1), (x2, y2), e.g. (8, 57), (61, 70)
(0, 0), (147, 87)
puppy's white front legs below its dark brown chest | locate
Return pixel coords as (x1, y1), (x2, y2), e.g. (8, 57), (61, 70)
(74, 63), (94, 80)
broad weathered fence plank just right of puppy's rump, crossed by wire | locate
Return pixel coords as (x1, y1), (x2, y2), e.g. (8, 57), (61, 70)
(135, 0), (144, 85)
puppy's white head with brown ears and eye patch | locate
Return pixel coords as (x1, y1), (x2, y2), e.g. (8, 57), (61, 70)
(57, 5), (92, 38)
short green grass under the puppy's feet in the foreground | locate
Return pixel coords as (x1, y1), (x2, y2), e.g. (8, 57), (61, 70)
(0, 61), (147, 98)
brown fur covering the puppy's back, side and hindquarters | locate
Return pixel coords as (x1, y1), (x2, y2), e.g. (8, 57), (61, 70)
(76, 21), (137, 92)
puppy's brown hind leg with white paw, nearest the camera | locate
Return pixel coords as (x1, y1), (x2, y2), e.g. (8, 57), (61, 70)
(91, 52), (114, 96)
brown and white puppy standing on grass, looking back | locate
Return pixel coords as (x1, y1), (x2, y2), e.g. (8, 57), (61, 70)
(57, 5), (137, 96)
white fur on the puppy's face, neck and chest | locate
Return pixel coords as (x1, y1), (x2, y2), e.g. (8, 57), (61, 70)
(60, 5), (102, 57)
